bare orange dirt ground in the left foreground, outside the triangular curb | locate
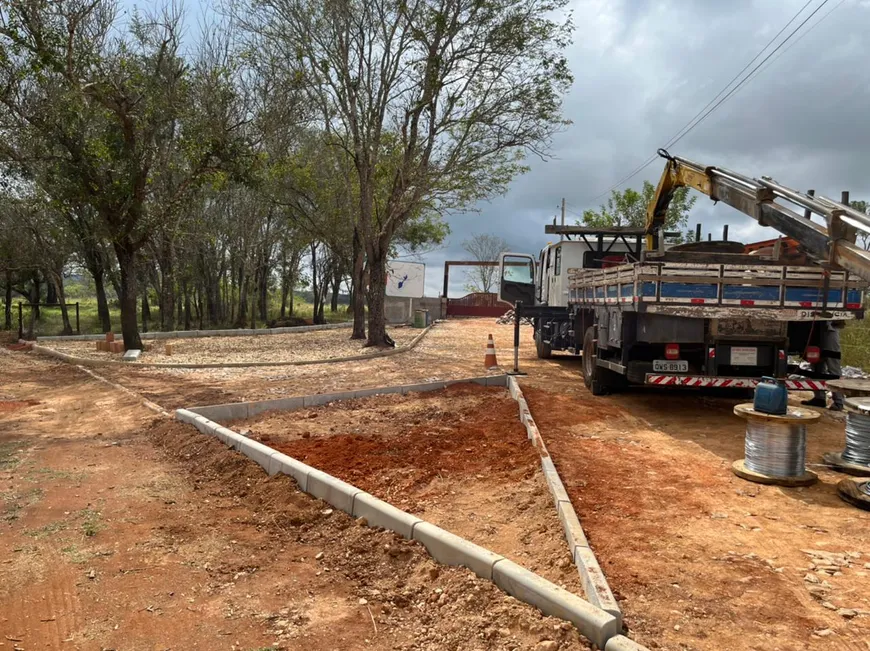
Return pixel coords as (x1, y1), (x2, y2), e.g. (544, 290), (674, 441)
(0, 352), (587, 651)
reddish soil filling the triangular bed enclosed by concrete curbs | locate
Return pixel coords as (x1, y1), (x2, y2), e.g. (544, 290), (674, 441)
(230, 384), (583, 595)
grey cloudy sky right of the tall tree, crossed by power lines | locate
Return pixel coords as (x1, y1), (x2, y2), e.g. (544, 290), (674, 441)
(426, 0), (870, 294)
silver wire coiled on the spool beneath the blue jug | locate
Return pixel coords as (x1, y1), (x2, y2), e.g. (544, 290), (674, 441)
(743, 419), (807, 477)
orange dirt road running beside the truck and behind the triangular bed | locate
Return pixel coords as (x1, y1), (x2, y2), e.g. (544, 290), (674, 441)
(10, 320), (870, 651)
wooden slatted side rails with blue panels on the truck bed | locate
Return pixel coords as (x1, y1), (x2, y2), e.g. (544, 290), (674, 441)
(568, 262), (867, 320)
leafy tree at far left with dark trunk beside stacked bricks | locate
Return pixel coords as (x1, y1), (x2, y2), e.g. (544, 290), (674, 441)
(0, 0), (252, 349)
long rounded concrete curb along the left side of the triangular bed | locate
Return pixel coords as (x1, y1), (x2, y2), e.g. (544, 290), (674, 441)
(175, 410), (621, 651)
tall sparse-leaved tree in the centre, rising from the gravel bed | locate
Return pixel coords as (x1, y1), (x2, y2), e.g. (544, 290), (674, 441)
(237, 0), (572, 346)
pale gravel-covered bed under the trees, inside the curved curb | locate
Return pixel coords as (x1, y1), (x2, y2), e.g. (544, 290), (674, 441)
(44, 328), (420, 364)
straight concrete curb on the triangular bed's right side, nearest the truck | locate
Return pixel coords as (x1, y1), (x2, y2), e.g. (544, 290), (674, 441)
(506, 376), (624, 628)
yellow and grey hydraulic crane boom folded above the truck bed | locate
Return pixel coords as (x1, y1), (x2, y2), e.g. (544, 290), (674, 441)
(646, 149), (870, 282)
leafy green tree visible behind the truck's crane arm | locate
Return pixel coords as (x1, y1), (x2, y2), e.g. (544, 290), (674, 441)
(583, 181), (698, 232)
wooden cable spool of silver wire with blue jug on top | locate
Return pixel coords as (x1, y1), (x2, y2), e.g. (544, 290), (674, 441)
(731, 404), (819, 486)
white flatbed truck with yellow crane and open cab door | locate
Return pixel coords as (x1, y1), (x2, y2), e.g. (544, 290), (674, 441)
(499, 150), (870, 395)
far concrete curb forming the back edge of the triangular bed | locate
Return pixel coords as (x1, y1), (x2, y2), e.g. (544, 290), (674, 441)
(189, 375), (508, 421)
